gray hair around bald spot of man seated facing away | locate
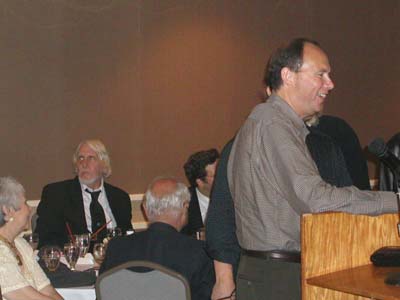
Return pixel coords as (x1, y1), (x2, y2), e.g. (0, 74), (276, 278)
(144, 177), (190, 221)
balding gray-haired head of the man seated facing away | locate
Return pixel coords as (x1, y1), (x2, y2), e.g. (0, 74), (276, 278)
(144, 177), (190, 230)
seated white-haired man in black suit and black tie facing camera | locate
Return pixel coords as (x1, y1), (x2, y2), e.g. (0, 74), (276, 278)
(35, 140), (132, 247)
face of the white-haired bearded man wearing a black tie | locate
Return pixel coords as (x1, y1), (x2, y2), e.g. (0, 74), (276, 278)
(76, 144), (104, 189)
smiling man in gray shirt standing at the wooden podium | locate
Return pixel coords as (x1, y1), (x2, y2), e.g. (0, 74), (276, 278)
(228, 39), (397, 300)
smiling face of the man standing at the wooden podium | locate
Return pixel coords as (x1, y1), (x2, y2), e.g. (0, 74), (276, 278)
(294, 43), (334, 119)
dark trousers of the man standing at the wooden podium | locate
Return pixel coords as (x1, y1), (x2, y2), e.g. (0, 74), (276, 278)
(236, 254), (301, 300)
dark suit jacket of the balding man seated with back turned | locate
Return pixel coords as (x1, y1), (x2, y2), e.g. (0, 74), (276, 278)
(100, 223), (215, 300)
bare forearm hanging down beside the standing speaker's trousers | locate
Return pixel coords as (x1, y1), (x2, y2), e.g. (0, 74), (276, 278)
(211, 260), (236, 300)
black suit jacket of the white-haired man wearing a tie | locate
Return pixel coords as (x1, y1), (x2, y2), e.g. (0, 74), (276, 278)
(35, 177), (132, 247)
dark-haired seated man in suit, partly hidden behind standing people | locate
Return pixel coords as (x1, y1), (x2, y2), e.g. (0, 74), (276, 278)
(182, 149), (219, 235)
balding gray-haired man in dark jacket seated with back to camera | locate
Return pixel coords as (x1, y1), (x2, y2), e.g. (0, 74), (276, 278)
(100, 178), (215, 300)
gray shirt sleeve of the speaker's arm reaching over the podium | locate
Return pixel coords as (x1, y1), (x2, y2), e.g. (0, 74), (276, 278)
(260, 123), (397, 215)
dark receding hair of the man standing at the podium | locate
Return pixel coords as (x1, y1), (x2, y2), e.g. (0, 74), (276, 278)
(264, 38), (320, 91)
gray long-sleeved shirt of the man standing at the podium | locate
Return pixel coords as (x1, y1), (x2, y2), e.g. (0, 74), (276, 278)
(228, 94), (397, 250)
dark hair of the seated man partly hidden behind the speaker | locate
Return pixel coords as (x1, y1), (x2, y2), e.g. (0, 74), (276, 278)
(183, 149), (219, 187)
